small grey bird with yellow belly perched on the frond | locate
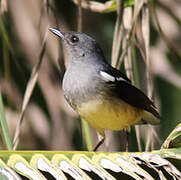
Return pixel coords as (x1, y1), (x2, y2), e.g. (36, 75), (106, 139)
(49, 28), (160, 151)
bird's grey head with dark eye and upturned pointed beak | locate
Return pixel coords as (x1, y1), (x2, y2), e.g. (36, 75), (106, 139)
(49, 28), (103, 61)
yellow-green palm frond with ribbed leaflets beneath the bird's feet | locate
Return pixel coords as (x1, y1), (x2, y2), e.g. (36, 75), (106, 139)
(0, 149), (181, 180)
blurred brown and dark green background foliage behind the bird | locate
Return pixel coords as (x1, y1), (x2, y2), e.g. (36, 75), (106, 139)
(0, 0), (181, 151)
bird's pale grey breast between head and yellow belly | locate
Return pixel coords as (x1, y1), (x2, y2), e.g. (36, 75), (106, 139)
(62, 67), (102, 109)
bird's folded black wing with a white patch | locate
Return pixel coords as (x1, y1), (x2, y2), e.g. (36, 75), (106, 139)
(100, 68), (160, 119)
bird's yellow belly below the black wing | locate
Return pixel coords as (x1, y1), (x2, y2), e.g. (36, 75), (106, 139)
(77, 97), (143, 132)
